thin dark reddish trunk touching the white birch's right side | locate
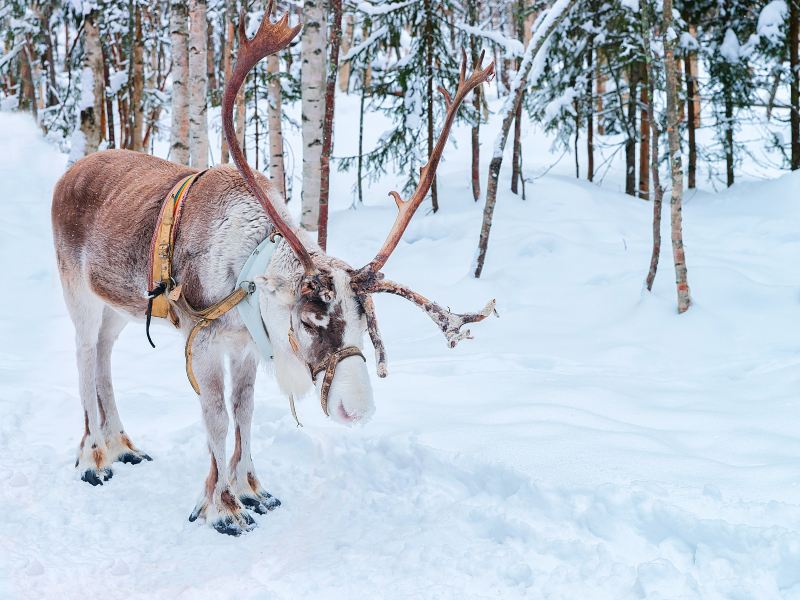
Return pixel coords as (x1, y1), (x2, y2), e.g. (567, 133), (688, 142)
(317, 0), (342, 252)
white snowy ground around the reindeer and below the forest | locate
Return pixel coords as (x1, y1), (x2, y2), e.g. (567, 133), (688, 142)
(0, 96), (800, 600)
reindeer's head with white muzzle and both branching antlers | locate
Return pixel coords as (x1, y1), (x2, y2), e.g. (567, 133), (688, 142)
(222, 1), (494, 423)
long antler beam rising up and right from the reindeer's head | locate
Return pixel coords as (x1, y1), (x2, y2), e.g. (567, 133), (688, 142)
(353, 53), (494, 285)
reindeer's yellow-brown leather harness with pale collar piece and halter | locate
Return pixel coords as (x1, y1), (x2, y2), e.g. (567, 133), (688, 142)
(145, 171), (366, 425)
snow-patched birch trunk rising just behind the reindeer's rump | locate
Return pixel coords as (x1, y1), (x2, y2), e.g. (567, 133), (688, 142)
(70, 10), (104, 161)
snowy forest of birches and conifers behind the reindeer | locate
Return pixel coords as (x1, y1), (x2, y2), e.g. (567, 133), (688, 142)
(0, 0), (800, 311)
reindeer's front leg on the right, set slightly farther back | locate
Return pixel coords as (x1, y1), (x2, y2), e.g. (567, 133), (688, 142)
(230, 352), (281, 515)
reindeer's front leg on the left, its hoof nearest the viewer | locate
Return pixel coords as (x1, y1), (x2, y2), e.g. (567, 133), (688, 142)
(189, 330), (255, 535)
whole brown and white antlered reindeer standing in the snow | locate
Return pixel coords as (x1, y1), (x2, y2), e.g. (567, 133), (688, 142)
(52, 3), (494, 535)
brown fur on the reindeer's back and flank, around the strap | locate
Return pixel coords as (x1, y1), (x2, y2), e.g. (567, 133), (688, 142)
(52, 150), (271, 317)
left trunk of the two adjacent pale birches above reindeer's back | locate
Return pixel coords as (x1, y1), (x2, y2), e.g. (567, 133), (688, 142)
(169, 0), (189, 165)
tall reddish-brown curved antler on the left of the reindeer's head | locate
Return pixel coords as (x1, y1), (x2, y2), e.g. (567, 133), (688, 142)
(222, 0), (316, 277)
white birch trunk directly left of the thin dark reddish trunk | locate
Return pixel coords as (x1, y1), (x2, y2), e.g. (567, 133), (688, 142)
(300, 0), (327, 231)
